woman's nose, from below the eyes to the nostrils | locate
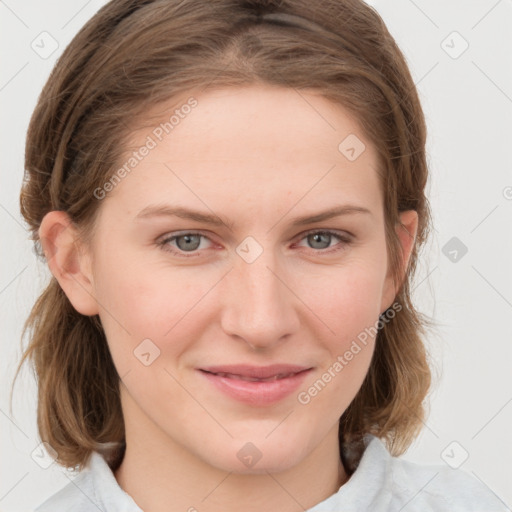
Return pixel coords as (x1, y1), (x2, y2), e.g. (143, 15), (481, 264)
(221, 246), (300, 349)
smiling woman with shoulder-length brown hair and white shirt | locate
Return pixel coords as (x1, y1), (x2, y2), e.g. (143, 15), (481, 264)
(13, 0), (503, 512)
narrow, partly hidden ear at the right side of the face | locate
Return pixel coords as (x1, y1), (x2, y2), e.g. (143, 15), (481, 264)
(381, 210), (418, 314)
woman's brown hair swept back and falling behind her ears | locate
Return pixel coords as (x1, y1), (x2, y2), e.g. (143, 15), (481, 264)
(11, 0), (431, 472)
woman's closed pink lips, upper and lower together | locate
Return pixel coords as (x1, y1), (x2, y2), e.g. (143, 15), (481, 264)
(197, 364), (312, 406)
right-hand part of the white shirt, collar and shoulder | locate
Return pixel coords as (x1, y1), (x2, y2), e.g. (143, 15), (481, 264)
(308, 434), (510, 512)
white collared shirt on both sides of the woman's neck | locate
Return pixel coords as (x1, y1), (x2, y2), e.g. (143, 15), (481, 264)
(35, 434), (510, 512)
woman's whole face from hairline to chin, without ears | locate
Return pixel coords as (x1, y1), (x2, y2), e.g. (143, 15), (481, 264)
(61, 86), (404, 472)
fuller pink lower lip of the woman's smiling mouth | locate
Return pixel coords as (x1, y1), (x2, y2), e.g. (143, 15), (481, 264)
(199, 369), (311, 405)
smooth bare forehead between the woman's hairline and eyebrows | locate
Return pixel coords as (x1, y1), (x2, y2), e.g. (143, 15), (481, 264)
(100, 86), (380, 223)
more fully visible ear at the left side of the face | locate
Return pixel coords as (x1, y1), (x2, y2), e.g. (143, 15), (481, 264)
(39, 210), (99, 316)
